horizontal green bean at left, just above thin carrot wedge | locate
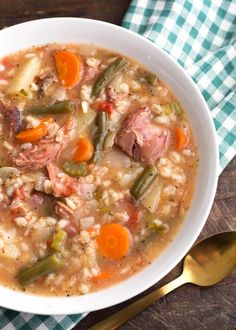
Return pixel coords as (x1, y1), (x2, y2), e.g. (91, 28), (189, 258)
(29, 100), (75, 115)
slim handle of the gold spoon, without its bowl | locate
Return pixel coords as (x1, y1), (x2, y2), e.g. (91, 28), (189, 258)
(90, 274), (187, 330)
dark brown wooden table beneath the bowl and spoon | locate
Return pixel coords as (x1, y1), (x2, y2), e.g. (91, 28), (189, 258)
(0, 0), (236, 330)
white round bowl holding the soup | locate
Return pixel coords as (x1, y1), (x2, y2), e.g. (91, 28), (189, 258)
(0, 18), (218, 314)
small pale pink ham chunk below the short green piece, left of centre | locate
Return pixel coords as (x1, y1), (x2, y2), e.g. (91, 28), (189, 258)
(47, 163), (94, 199)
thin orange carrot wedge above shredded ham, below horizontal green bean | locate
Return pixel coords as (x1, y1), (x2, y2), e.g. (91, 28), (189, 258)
(16, 117), (53, 142)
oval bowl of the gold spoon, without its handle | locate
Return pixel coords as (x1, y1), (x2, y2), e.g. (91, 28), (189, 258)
(183, 232), (236, 286)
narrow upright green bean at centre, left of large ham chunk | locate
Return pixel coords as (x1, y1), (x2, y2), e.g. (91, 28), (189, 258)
(91, 111), (107, 163)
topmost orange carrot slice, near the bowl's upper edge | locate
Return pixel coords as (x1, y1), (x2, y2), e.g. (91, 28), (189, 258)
(54, 50), (81, 87)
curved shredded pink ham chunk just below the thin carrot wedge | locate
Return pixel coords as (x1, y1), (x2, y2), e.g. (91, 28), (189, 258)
(11, 117), (75, 170)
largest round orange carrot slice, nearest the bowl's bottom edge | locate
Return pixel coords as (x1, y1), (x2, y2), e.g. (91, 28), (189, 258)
(97, 223), (131, 260)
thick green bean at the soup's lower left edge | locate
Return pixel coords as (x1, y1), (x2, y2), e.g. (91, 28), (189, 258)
(18, 254), (64, 285)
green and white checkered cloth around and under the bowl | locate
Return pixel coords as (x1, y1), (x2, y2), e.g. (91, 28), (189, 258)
(0, 0), (236, 330)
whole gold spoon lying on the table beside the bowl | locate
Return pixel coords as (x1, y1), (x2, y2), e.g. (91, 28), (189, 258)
(90, 231), (236, 330)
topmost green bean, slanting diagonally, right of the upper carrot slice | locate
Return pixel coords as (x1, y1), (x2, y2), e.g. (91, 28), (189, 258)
(92, 57), (128, 97)
